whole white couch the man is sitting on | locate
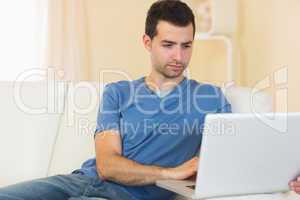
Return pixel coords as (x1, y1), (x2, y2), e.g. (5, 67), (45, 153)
(0, 81), (299, 200)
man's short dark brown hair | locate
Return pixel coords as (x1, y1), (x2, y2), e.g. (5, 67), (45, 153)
(145, 0), (196, 39)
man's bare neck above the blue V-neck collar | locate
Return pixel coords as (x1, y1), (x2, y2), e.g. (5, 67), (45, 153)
(145, 72), (184, 91)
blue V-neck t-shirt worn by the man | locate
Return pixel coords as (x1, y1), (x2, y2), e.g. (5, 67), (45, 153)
(76, 77), (231, 200)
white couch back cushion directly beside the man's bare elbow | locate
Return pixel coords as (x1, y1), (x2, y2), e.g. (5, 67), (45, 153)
(48, 82), (102, 175)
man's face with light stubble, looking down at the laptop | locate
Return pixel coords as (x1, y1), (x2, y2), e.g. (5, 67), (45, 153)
(144, 21), (193, 78)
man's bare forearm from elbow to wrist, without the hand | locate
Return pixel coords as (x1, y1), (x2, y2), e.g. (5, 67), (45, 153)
(97, 155), (169, 185)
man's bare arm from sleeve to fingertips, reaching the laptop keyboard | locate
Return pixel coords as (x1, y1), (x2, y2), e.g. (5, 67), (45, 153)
(95, 131), (198, 185)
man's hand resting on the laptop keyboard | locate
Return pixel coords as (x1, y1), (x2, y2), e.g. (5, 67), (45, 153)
(164, 157), (199, 180)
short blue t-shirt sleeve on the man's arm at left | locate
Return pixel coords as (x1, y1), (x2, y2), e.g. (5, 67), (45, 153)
(95, 84), (120, 138)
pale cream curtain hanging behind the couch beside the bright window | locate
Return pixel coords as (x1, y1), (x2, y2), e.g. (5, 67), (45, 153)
(46, 0), (89, 81)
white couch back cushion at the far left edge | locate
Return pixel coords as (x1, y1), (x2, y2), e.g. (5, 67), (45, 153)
(0, 82), (64, 186)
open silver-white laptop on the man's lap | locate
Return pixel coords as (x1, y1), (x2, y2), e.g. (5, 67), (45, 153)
(156, 113), (300, 199)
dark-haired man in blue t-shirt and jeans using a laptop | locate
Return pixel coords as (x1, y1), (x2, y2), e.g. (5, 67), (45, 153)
(0, 0), (300, 200)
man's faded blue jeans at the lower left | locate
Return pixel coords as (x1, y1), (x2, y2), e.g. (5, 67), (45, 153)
(0, 174), (134, 200)
